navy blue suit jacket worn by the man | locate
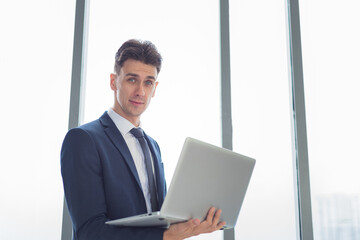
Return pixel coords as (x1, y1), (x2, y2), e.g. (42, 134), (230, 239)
(61, 113), (166, 240)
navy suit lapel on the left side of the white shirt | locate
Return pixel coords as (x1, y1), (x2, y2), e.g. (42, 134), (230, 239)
(100, 112), (142, 189)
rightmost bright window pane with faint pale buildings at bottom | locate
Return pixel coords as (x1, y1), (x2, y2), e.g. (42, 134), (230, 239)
(300, 0), (360, 240)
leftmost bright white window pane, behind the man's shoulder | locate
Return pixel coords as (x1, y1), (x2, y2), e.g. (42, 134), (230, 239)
(0, 0), (75, 240)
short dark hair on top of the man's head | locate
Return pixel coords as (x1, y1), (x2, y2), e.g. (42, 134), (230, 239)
(114, 39), (162, 74)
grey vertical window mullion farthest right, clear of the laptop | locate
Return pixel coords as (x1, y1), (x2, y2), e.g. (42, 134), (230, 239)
(287, 0), (313, 240)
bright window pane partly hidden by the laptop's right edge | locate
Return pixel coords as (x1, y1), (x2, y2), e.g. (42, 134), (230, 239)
(230, 0), (297, 240)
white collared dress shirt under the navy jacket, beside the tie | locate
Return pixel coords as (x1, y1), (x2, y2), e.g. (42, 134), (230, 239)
(108, 108), (151, 212)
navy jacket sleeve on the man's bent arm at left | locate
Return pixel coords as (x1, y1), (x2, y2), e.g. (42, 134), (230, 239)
(61, 128), (165, 240)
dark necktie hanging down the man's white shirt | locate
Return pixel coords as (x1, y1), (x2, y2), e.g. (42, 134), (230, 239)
(130, 128), (159, 212)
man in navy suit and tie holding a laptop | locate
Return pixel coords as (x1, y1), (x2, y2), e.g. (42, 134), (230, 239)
(61, 40), (225, 240)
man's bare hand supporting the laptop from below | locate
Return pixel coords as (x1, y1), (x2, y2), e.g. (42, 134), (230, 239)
(163, 207), (226, 240)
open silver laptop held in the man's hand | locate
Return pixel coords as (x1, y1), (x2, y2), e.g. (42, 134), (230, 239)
(106, 138), (255, 228)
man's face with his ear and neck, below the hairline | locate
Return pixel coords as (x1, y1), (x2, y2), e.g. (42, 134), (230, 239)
(110, 59), (158, 126)
